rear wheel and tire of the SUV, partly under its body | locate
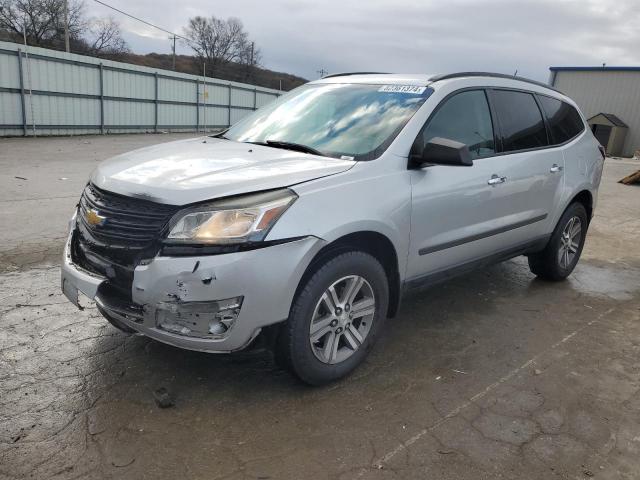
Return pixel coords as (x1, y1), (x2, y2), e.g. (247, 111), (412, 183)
(529, 202), (589, 282)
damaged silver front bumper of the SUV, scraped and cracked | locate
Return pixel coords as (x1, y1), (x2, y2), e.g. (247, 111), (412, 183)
(61, 234), (325, 352)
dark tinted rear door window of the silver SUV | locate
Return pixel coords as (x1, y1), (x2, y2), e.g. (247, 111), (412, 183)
(492, 90), (549, 152)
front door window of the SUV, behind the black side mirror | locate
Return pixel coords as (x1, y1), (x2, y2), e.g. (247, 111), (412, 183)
(422, 90), (496, 159)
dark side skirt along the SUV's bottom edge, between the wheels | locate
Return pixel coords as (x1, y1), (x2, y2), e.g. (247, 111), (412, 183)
(403, 234), (551, 293)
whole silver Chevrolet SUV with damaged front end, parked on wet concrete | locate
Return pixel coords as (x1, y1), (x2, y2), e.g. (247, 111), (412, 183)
(62, 73), (604, 384)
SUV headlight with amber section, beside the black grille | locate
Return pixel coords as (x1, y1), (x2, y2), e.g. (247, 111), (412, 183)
(167, 190), (298, 244)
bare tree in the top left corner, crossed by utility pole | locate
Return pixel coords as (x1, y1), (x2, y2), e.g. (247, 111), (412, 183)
(0, 0), (86, 46)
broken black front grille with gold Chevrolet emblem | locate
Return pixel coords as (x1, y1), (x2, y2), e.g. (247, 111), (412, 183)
(71, 184), (179, 297)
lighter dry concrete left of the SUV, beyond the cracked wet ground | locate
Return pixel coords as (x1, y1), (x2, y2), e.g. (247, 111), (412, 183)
(0, 133), (195, 272)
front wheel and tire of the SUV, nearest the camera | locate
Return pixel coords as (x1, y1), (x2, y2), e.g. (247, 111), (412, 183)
(275, 251), (389, 385)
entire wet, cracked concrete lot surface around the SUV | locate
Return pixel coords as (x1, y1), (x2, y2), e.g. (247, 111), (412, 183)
(0, 135), (640, 480)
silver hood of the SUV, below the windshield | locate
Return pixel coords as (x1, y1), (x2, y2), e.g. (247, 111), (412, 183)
(91, 137), (355, 205)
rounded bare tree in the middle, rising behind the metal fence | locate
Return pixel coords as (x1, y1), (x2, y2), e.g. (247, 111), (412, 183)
(184, 16), (259, 68)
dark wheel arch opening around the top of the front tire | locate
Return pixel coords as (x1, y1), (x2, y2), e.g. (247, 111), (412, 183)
(294, 230), (401, 318)
